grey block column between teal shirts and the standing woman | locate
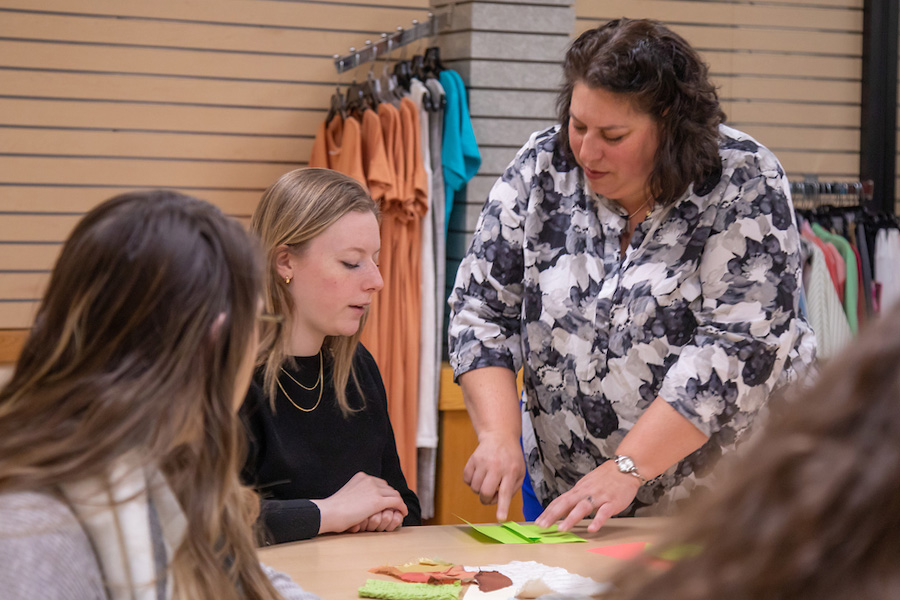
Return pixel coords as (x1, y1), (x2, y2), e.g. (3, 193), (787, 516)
(431, 0), (575, 338)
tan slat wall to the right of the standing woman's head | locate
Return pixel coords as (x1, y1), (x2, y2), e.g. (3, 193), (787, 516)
(576, 0), (863, 185)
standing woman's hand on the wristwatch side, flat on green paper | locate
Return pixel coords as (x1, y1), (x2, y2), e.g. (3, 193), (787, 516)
(535, 460), (641, 533)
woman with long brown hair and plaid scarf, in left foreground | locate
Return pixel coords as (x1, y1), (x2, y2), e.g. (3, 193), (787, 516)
(0, 192), (314, 600)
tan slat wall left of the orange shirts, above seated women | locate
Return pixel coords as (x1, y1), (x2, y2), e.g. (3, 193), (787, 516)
(0, 0), (429, 338)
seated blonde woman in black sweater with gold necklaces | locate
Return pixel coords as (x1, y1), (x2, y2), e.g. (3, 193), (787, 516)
(242, 169), (421, 543)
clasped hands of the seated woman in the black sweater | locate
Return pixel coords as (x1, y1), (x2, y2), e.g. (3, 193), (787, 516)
(312, 472), (409, 533)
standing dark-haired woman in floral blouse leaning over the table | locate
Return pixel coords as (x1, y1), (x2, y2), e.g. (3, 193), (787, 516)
(450, 19), (814, 531)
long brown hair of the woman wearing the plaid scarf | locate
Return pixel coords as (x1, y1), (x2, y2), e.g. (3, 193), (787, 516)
(0, 191), (278, 600)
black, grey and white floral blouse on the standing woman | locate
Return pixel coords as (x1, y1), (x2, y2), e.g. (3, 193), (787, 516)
(449, 125), (815, 514)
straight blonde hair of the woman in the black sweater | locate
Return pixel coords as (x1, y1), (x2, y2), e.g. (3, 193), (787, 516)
(250, 168), (378, 416)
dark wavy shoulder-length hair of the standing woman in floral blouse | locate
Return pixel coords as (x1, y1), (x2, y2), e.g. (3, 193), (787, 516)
(556, 18), (725, 204)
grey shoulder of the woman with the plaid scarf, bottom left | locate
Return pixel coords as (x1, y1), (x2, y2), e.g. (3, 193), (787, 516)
(0, 492), (106, 599)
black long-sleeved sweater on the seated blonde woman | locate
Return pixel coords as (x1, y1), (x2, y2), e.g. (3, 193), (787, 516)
(241, 344), (421, 544)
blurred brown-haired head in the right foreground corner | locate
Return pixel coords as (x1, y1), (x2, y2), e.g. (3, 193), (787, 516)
(615, 309), (900, 600)
